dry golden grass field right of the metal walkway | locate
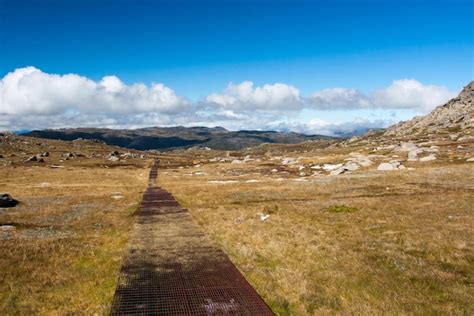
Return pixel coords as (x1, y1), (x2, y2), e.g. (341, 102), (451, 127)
(159, 156), (474, 315)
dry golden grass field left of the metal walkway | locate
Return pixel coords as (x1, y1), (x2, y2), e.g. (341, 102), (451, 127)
(0, 137), (150, 315)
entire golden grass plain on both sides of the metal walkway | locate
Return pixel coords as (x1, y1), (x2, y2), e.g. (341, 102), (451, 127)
(0, 138), (474, 315)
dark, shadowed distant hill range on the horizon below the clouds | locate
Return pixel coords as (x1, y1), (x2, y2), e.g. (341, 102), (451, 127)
(23, 126), (334, 150)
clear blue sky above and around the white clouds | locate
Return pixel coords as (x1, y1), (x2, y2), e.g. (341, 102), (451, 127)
(0, 0), (474, 134)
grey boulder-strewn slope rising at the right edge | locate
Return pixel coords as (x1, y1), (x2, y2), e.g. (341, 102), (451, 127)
(385, 81), (474, 136)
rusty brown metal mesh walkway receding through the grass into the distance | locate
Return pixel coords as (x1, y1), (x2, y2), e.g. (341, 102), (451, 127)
(111, 161), (273, 315)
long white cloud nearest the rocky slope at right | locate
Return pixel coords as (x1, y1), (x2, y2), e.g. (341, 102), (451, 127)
(307, 79), (456, 112)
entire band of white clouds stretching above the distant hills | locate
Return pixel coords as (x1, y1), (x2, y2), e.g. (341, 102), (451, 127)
(0, 67), (455, 136)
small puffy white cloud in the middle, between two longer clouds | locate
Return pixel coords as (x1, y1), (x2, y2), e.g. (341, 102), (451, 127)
(205, 81), (301, 111)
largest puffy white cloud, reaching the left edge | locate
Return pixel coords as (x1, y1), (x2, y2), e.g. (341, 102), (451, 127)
(0, 67), (190, 115)
